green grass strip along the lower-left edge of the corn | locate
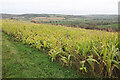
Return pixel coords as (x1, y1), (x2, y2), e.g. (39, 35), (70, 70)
(2, 32), (81, 78)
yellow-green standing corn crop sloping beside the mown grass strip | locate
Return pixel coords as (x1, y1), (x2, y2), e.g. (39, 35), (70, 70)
(2, 18), (120, 78)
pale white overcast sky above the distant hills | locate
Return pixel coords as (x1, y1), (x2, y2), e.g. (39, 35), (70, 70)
(0, 0), (119, 15)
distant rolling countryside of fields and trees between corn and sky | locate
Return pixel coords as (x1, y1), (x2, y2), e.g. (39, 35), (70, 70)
(3, 14), (118, 32)
